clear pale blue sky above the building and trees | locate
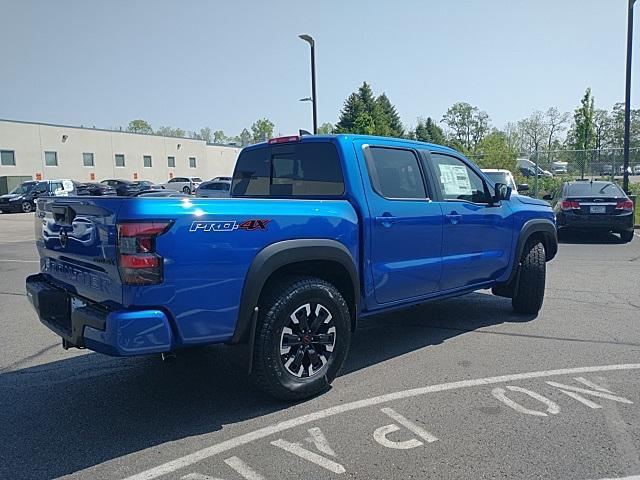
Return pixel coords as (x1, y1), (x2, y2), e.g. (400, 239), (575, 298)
(0, 0), (640, 135)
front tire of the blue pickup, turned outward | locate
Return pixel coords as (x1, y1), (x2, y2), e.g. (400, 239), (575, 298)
(511, 240), (547, 314)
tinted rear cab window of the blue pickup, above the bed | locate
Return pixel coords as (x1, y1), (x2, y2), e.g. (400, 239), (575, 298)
(232, 142), (344, 197)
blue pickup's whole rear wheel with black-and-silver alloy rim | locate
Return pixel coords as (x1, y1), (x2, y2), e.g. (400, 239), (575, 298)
(252, 277), (351, 400)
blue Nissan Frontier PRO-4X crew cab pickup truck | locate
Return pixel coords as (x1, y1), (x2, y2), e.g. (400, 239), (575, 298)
(26, 135), (557, 399)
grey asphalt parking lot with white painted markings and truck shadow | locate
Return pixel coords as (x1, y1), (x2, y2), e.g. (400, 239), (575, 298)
(0, 214), (640, 480)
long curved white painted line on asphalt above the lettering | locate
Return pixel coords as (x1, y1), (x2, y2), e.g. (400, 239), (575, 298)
(125, 363), (640, 480)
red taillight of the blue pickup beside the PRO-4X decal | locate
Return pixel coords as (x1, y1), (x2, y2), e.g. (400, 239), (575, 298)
(118, 222), (171, 285)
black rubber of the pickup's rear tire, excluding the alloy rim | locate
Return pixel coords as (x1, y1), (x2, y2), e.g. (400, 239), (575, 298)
(262, 280), (351, 397)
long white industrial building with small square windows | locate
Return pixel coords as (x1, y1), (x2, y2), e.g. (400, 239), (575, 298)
(0, 120), (240, 191)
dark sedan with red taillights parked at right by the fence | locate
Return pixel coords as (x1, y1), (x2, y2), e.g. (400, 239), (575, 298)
(545, 180), (634, 242)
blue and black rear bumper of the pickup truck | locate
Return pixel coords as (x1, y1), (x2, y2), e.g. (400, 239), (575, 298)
(26, 273), (174, 357)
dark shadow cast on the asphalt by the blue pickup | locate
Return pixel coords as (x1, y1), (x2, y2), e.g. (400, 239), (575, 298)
(0, 293), (533, 479)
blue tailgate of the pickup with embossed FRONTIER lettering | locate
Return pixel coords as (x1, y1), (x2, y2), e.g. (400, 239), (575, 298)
(35, 197), (122, 307)
